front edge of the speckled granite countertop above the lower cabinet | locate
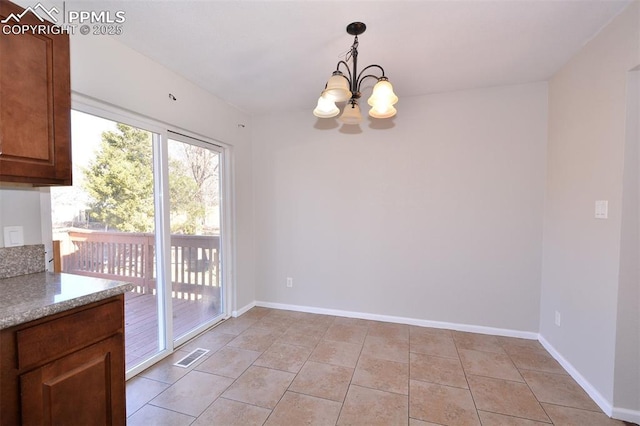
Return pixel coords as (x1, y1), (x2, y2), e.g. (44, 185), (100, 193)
(0, 282), (134, 330)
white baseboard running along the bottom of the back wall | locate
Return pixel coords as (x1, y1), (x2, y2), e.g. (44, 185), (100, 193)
(255, 301), (538, 340)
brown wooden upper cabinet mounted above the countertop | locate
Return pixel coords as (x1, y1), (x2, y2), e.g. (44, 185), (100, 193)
(0, 0), (71, 185)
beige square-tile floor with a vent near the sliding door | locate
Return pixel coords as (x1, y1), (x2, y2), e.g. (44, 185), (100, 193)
(127, 308), (624, 426)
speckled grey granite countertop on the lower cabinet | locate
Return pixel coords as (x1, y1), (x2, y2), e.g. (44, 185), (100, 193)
(0, 272), (133, 330)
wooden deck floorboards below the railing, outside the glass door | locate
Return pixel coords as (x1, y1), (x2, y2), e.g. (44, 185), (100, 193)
(124, 292), (220, 370)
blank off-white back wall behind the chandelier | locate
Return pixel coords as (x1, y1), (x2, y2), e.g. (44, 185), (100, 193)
(252, 83), (547, 332)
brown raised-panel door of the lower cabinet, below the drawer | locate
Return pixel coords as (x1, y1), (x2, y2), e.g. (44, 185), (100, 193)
(20, 334), (126, 426)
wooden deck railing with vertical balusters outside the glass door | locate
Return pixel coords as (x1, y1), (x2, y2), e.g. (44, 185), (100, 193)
(61, 230), (220, 300)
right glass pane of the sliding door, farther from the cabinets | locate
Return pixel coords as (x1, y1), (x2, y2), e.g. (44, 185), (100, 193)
(167, 134), (223, 341)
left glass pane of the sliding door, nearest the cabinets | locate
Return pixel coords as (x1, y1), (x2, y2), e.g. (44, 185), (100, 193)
(51, 111), (166, 369)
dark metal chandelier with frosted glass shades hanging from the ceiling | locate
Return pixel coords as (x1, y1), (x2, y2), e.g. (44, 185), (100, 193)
(313, 22), (398, 124)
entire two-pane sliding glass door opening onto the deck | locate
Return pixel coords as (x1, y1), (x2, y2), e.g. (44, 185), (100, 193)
(51, 111), (225, 373)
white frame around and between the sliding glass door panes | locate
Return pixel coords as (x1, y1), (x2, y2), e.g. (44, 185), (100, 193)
(40, 93), (236, 380)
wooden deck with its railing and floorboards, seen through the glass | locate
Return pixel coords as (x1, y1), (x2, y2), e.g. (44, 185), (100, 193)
(56, 228), (222, 369)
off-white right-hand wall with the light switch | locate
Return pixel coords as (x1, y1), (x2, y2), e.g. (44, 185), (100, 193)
(540, 2), (640, 411)
